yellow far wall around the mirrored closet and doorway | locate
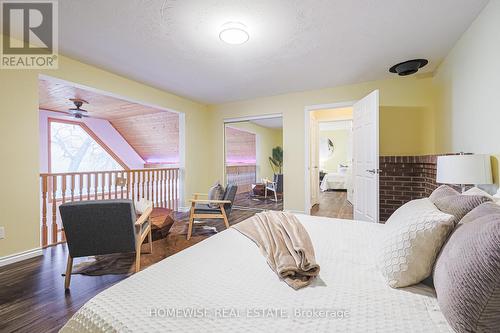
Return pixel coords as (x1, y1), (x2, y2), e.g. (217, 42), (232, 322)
(210, 77), (436, 211)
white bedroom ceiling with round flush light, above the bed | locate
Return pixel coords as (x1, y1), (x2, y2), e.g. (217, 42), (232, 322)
(59, 0), (487, 103)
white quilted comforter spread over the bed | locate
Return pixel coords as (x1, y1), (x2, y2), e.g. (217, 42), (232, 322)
(62, 215), (452, 333)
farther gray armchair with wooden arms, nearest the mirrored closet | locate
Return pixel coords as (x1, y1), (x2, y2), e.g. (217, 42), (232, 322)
(187, 184), (238, 240)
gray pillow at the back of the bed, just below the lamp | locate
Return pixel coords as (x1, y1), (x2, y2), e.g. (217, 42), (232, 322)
(434, 194), (491, 223)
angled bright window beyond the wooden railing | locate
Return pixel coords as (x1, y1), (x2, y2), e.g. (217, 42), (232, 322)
(49, 119), (123, 173)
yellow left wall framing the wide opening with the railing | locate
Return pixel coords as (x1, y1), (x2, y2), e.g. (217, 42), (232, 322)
(0, 56), (215, 257)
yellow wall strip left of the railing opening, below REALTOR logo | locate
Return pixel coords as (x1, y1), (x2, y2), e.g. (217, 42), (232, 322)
(0, 70), (40, 257)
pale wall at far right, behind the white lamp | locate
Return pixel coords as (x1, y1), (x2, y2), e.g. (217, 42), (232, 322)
(433, 0), (500, 184)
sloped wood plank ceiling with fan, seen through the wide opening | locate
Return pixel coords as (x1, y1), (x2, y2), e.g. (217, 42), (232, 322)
(38, 79), (179, 164)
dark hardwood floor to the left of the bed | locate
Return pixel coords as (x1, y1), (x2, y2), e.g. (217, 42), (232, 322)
(0, 209), (264, 333)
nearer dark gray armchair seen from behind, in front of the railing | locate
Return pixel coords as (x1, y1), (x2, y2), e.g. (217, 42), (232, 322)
(59, 200), (153, 289)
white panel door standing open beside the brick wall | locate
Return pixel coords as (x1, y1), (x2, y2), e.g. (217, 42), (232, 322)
(353, 90), (379, 223)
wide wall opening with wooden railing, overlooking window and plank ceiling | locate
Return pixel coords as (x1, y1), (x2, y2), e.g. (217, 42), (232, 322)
(38, 76), (185, 247)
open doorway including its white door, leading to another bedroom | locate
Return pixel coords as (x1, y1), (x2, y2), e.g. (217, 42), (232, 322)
(304, 90), (380, 223)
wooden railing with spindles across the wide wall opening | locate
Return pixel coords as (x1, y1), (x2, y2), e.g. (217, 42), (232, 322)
(40, 168), (180, 247)
